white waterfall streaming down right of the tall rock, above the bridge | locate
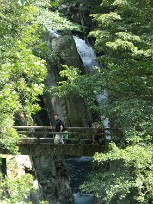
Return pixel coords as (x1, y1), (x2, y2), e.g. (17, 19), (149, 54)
(73, 36), (111, 140)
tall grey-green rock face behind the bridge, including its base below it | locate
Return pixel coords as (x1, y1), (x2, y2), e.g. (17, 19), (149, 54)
(32, 35), (93, 204)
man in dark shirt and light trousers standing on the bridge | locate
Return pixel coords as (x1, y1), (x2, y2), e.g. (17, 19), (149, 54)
(54, 114), (64, 144)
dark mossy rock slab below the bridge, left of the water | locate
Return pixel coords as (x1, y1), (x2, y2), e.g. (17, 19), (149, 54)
(33, 156), (73, 204)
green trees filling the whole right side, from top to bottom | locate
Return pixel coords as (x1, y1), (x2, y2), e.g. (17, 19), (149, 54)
(52, 0), (153, 204)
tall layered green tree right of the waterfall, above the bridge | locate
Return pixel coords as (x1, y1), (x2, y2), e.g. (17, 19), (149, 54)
(90, 0), (153, 134)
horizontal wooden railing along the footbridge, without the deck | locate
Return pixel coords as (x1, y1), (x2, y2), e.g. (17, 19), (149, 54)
(14, 126), (122, 143)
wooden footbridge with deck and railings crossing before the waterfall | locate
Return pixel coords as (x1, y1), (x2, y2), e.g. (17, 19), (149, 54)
(0, 126), (120, 156)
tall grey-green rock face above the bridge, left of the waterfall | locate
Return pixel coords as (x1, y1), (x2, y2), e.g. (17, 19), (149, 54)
(43, 35), (91, 126)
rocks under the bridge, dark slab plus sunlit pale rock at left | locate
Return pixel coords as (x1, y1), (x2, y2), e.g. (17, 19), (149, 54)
(7, 155), (73, 204)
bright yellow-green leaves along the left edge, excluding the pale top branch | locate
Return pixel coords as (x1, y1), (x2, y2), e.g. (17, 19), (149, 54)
(0, 1), (46, 152)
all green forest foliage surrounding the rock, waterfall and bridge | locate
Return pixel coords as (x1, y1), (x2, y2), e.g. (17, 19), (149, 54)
(0, 0), (153, 204)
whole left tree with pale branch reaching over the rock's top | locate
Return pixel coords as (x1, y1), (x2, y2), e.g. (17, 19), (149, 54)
(0, 0), (79, 151)
